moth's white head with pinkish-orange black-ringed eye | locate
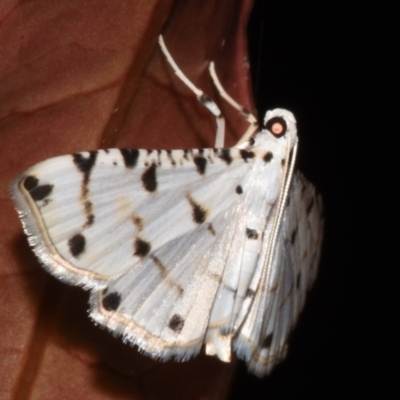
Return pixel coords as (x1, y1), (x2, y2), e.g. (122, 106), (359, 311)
(263, 108), (297, 147)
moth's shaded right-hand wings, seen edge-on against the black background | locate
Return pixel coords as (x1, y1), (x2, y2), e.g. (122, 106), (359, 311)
(234, 172), (323, 377)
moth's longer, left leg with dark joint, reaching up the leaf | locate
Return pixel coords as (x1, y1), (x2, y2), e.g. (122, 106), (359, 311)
(158, 35), (225, 147)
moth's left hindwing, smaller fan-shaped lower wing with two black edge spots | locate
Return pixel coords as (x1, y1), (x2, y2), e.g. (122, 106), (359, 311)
(90, 193), (245, 360)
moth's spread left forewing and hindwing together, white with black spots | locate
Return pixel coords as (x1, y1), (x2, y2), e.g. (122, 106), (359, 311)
(11, 149), (253, 359)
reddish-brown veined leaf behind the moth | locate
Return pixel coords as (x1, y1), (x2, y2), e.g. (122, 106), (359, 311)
(0, 0), (252, 400)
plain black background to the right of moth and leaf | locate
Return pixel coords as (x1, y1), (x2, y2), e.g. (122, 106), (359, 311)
(230, 0), (400, 399)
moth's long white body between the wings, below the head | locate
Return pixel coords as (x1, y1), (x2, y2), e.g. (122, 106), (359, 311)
(206, 148), (284, 361)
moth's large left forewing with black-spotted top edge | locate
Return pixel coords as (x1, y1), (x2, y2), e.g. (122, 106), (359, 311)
(10, 149), (248, 290)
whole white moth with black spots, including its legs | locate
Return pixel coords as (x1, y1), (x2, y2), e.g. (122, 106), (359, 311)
(11, 38), (323, 377)
